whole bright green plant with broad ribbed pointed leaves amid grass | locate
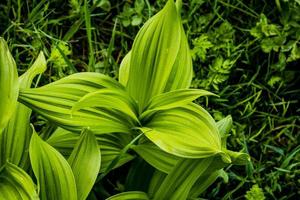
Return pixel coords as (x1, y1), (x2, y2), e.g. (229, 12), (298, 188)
(0, 0), (249, 200)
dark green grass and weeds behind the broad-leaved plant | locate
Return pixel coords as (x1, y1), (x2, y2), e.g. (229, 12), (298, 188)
(0, 0), (300, 200)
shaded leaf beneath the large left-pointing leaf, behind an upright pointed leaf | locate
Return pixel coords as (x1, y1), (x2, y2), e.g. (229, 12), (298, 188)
(47, 128), (134, 172)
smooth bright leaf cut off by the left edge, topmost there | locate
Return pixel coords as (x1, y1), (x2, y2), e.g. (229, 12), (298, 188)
(0, 37), (19, 131)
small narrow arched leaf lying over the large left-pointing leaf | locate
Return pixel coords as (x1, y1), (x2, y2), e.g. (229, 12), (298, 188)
(72, 89), (138, 122)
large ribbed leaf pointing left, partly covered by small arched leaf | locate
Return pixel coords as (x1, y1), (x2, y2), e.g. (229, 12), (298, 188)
(19, 72), (135, 135)
